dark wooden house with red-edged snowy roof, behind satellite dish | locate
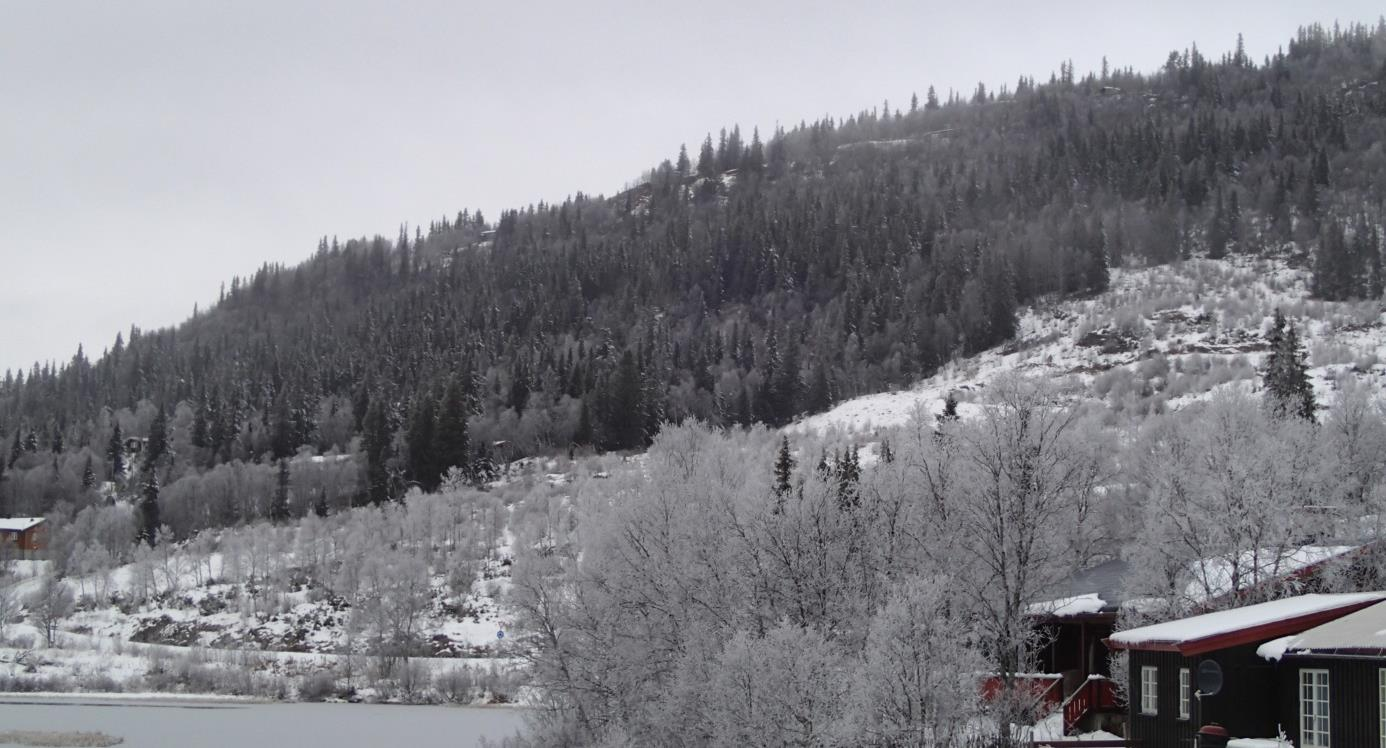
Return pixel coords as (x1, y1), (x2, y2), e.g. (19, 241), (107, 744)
(1107, 593), (1386, 748)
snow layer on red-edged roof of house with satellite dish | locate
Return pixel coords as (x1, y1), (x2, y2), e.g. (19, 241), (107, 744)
(1107, 593), (1386, 655)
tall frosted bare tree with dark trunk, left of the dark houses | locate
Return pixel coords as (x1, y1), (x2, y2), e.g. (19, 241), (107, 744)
(918, 377), (1103, 718)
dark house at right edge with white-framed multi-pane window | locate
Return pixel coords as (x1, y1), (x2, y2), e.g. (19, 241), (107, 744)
(1260, 604), (1386, 748)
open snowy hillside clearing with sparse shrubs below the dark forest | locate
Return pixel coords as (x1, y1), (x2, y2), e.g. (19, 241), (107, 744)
(789, 258), (1386, 434)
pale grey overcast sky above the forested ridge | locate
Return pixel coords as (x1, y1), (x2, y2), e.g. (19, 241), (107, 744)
(0, 0), (1380, 370)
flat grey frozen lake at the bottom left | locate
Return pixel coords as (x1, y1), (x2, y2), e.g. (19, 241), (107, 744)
(0, 695), (524, 748)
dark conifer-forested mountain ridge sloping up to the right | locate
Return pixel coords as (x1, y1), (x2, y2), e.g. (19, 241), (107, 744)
(0, 22), (1386, 518)
